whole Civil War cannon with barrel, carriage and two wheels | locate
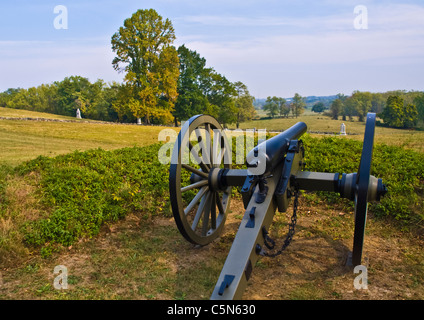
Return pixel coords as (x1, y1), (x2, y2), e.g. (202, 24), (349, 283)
(169, 113), (387, 300)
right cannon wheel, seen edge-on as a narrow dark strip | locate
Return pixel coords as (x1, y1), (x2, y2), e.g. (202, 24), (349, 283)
(352, 113), (376, 266)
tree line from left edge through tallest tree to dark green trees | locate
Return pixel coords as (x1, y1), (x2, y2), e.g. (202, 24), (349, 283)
(0, 9), (255, 125)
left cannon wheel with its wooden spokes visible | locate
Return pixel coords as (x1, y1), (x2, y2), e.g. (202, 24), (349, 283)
(169, 115), (232, 246)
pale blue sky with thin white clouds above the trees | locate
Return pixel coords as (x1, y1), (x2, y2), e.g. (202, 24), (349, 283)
(0, 0), (424, 98)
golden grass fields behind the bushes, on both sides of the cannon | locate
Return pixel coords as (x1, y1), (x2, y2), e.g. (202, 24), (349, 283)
(0, 108), (424, 166)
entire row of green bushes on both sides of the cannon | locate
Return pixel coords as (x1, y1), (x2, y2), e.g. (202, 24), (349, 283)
(16, 135), (424, 253)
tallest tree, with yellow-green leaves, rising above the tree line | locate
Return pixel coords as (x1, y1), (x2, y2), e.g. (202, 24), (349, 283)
(111, 9), (179, 123)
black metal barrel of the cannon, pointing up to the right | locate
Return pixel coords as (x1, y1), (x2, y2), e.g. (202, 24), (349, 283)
(246, 122), (307, 175)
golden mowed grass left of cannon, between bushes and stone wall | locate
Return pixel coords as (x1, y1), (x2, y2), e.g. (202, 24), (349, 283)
(0, 115), (176, 166)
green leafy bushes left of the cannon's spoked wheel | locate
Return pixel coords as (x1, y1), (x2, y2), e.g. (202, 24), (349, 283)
(16, 145), (169, 252)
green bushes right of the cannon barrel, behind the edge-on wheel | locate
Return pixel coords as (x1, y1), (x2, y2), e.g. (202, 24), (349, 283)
(303, 135), (424, 224)
